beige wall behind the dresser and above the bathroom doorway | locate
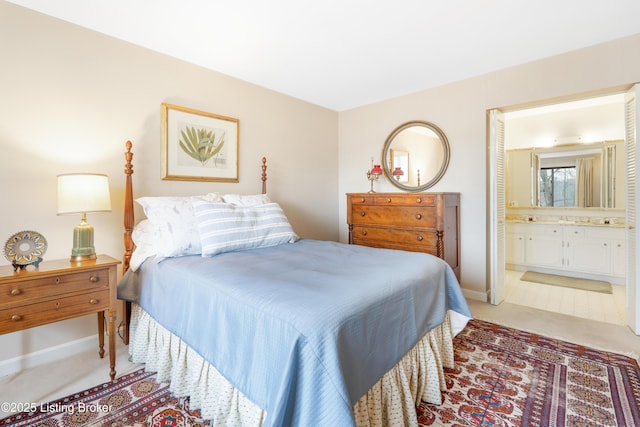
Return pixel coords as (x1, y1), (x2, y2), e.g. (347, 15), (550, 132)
(338, 35), (640, 298)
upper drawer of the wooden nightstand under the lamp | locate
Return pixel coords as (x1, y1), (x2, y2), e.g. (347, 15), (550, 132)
(0, 268), (109, 309)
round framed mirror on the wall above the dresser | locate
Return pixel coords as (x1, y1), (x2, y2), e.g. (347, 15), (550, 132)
(382, 121), (449, 191)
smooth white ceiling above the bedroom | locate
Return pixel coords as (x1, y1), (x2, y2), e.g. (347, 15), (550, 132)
(9, 0), (640, 111)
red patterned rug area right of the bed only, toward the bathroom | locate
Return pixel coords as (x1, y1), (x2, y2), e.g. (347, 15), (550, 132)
(418, 320), (640, 427)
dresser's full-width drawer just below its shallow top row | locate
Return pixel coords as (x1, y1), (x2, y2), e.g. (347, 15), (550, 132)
(351, 205), (437, 229)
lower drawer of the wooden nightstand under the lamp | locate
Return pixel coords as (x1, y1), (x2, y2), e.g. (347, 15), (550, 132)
(0, 289), (109, 333)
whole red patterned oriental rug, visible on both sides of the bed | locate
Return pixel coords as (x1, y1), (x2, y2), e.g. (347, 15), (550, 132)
(0, 320), (640, 427)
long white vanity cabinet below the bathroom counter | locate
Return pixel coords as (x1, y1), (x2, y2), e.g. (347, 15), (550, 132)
(505, 223), (626, 277)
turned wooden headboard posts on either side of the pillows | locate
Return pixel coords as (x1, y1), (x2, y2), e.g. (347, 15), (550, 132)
(122, 141), (267, 344)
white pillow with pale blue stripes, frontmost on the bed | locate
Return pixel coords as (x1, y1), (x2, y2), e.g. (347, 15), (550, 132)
(191, 197), (298, 256)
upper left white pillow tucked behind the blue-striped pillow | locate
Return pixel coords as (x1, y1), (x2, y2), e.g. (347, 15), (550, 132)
(136, 193), (222, 257)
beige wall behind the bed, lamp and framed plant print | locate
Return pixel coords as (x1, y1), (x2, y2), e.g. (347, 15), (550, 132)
(0, 1), (338, 364)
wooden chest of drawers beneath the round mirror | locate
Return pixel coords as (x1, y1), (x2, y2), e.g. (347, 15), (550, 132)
(347, 193), (460, 280)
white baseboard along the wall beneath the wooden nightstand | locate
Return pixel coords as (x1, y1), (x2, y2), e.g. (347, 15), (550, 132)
(0, 334), (98, 377)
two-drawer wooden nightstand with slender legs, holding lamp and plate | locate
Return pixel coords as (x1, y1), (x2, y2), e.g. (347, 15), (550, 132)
(0, 255), (120, 380)
